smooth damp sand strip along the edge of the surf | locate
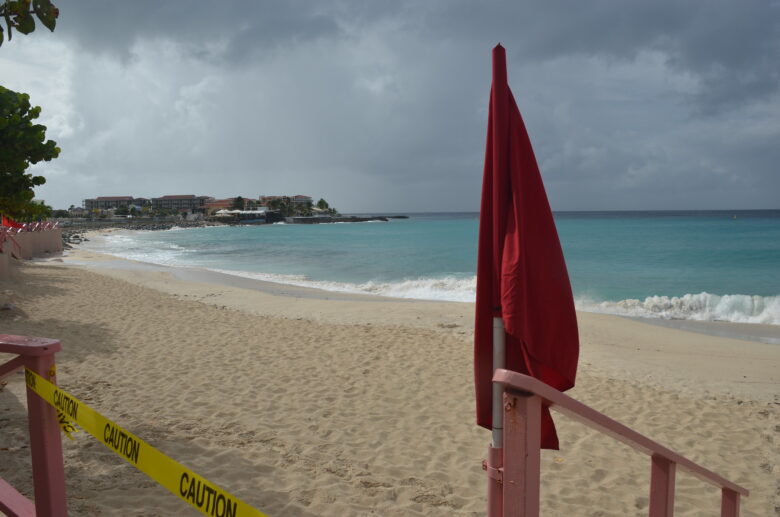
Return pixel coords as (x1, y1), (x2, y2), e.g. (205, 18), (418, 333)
(47, 247), (780, 400)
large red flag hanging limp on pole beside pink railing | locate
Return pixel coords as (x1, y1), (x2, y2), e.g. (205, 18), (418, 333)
(474, 45), (579, 449)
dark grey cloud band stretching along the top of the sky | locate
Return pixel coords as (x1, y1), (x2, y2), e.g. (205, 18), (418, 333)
(56, 0), (780, 113)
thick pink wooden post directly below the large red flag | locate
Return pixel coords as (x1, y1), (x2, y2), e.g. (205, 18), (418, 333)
(503, 391), (542, 517)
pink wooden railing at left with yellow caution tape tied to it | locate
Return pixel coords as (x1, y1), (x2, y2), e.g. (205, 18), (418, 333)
(0, 334), (68, 517)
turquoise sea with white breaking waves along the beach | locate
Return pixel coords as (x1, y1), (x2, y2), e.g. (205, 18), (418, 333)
(85, 210), (780, 325)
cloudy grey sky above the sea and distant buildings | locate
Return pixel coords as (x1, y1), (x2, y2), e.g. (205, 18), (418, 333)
(0, 0), (780, 212)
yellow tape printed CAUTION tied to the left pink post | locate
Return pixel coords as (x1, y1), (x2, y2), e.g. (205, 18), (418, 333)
(24, 368), (265, 517)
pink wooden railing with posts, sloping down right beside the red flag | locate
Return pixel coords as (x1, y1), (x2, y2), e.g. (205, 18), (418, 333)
(490, 369), (749, 517)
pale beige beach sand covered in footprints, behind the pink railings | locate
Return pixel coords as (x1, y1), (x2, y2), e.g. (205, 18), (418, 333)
(0, 252), (780, 517)
